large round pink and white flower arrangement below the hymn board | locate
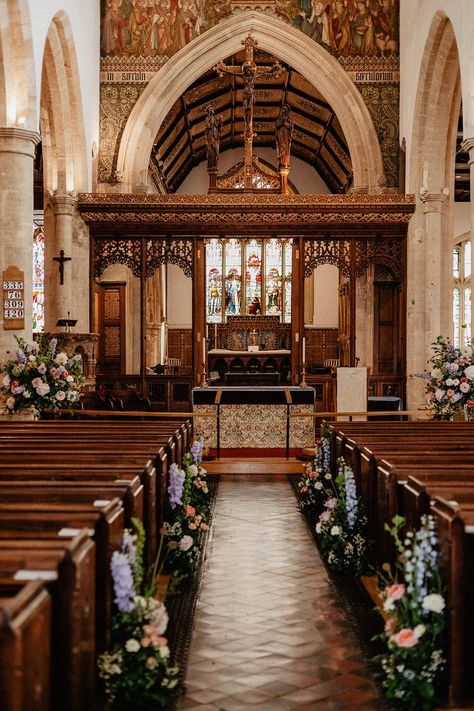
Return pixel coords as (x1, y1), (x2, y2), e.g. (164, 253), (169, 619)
(0, 335), (83, 416)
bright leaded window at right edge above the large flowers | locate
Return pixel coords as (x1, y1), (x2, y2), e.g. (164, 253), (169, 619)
(453, 239), (472, 347)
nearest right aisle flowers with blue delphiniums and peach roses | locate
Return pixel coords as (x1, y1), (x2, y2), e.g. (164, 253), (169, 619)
(376, 516), (446, 711)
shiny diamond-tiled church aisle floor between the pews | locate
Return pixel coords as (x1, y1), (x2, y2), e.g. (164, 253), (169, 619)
(178, 479), (384, 711)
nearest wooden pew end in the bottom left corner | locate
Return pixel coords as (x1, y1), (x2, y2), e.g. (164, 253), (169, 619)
(0, 580), (51, 711)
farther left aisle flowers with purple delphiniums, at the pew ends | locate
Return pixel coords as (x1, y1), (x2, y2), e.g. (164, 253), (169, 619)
(162, 440), (209, 592)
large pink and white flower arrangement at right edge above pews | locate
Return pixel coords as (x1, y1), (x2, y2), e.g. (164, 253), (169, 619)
(423, 336), (474, 420)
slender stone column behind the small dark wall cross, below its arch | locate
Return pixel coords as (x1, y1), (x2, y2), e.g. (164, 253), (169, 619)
(45, 195), (77, 330)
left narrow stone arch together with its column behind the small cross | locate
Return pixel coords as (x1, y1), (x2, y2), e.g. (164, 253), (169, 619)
(40, 10), (89, 331)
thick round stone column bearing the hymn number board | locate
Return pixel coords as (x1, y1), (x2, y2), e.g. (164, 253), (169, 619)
(0, 127), (40, 361)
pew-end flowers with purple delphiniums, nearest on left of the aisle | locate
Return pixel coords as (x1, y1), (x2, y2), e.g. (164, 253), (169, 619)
(98, 519), (178, 711)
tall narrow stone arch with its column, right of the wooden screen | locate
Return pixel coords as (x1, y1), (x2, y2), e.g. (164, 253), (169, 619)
(406, 12), (461, 408)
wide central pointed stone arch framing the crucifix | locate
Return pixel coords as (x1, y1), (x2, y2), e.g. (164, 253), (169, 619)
(117, 11), (385, 192)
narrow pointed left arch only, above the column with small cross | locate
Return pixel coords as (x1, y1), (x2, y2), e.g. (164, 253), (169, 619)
(40, 10), (87, 192)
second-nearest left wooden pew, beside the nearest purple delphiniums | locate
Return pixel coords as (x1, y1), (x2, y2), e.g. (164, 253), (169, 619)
(0, 531), (96, 711)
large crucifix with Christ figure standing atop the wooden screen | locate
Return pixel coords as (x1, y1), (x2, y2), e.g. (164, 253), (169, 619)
(214, 33), (283, 190)
